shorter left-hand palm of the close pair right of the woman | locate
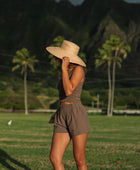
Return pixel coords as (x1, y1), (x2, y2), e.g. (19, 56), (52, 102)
(95, 41), (112, 116)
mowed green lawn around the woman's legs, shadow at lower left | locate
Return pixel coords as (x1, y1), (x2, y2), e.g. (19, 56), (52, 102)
(0, 113), (140, 170)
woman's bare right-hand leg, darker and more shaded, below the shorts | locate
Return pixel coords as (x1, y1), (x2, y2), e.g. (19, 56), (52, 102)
(72, 133), (88, 170)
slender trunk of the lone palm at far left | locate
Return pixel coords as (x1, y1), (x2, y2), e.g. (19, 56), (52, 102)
(24, 64), (28, 115)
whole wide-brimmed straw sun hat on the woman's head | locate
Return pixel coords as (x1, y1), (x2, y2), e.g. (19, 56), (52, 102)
(46, 40), (86, 67)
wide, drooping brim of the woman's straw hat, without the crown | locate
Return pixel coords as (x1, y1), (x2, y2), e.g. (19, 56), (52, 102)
(46, 47), (86, 67)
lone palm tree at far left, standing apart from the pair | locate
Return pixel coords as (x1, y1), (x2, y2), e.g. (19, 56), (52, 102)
(12, 48), (38, 115)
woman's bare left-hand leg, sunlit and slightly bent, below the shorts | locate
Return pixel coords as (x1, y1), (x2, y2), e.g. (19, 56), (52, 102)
(50, 133), (70, 170)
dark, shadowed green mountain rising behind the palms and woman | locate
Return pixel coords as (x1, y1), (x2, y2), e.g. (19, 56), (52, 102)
(0, 0), (140, 110)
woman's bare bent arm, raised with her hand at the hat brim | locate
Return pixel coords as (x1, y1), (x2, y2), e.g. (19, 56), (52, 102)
(62, 57), (84, 96)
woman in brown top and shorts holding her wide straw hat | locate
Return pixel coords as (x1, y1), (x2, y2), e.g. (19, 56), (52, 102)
(46, 40), (90, 170)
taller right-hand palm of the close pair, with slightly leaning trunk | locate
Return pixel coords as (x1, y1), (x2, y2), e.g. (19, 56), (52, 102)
(109, 35), (131, 115)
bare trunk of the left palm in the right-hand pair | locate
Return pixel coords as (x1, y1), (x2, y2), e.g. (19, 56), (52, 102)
(107, 61), (111, 116)
